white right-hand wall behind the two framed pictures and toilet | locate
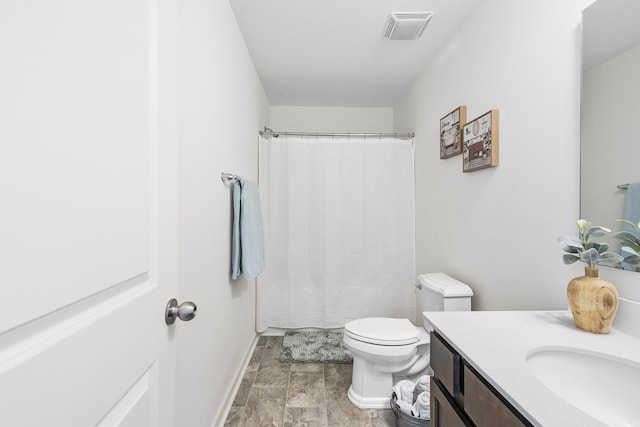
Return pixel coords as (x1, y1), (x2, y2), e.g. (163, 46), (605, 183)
(394, 0), (590, 310)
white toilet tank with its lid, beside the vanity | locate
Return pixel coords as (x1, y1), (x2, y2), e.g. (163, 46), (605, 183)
(416, 273), (473, 317)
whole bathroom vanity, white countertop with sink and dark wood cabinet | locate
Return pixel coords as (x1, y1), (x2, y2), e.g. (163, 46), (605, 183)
(423, 311), (640, 427)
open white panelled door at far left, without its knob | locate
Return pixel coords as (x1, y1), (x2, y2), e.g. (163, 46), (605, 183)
(0, 0), (176, 427)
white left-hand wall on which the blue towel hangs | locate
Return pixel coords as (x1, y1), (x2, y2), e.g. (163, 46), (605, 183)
(175, 0), (269, 427)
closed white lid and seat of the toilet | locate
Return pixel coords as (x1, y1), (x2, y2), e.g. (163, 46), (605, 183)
(344, 317), (418, 345)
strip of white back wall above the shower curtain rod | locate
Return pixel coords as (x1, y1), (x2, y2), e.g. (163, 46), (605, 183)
(270, 106), (393, 133)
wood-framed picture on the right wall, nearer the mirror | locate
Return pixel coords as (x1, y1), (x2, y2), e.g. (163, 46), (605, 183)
(462, 110), (498, 172)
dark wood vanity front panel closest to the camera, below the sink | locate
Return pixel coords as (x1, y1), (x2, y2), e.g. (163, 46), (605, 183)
(464, 363), (531, 427)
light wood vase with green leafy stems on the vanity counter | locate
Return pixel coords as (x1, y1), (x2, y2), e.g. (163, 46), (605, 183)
(558, 219), (623, 334)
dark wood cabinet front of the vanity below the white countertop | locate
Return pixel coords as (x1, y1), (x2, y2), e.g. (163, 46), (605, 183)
(431, 331), (532, 427)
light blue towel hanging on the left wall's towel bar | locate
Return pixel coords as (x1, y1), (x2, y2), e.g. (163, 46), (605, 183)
(231, 177), (266, 280)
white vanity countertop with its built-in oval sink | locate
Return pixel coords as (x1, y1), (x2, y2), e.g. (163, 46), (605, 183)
(423, 302), (640, 427)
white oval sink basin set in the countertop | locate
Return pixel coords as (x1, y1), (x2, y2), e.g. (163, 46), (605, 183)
(527, 347), (640, 427)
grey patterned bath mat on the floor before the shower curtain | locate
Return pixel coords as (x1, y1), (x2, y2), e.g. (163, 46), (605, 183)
(280, 330), (353, 363)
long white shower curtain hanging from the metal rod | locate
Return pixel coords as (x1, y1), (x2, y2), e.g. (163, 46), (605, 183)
(256, 135), (415, 332)
